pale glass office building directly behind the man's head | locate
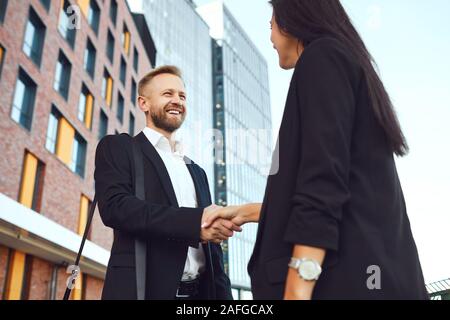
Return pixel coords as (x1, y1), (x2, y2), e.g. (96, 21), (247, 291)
(140, 0), (214, 190)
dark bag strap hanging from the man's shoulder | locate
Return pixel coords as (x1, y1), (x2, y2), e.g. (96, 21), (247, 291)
(63, 138), (147, 300)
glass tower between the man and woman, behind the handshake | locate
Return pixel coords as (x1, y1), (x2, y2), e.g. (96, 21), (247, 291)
(197, 1), (272, 299)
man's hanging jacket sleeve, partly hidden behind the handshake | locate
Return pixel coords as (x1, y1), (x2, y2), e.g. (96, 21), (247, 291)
(201, 169), (233, 300)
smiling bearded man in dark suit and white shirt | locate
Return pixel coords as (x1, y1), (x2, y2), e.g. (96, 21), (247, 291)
(95, 66), (237, 300)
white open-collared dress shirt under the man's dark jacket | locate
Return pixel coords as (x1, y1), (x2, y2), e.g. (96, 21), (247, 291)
(144, 127), (205, 281)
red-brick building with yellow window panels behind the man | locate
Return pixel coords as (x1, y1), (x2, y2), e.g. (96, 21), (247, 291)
(0, 0), (155, 299)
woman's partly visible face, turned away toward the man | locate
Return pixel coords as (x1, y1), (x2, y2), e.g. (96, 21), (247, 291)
(270, 15), (303, 70)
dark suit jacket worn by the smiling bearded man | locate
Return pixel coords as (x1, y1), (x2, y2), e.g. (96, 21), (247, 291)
(95, 132), (232, 300)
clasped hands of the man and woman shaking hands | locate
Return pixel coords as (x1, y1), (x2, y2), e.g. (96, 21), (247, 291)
(200, 203), (261, 244)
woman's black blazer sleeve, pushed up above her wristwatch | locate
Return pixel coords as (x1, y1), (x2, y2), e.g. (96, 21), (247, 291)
(285, 42), (356, 251)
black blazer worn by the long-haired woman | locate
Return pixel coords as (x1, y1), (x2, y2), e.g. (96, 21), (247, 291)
(248, 38), (427, 299)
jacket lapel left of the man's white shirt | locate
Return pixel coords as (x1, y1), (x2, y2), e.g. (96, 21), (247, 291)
(137, 132), (178, 207)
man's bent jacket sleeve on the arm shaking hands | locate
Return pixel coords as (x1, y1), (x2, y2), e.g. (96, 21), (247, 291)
(94, 135), (203, 247)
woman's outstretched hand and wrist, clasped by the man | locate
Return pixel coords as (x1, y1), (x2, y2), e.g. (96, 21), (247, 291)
(202, 203), (261, 228)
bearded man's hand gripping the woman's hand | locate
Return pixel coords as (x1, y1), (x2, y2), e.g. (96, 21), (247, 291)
(200, 204), (242, 244)
